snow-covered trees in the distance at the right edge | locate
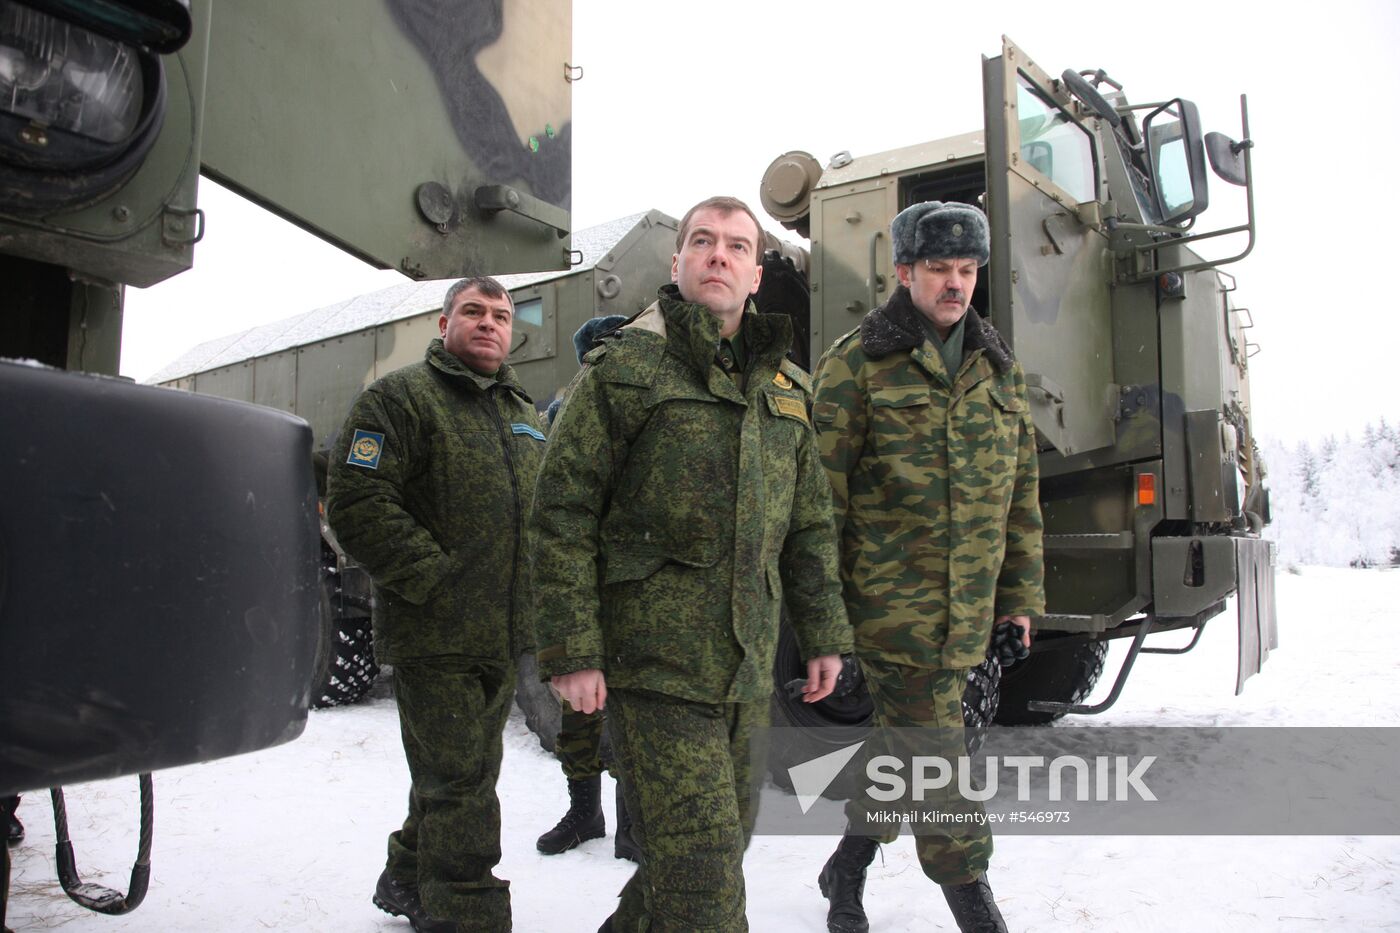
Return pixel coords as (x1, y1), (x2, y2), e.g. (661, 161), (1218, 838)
(1261, 419), (1400, 567)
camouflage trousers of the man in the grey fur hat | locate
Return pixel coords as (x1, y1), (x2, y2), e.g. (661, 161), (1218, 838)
(846, 656), (991, 884)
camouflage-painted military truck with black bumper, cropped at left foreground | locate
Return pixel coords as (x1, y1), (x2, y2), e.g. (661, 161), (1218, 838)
(0, 0), (577, 919)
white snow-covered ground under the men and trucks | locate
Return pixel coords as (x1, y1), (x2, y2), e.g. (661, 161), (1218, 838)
(8, 567), (1400, 933)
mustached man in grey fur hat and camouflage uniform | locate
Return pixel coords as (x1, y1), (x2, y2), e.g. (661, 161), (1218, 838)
(813, 202), (1044, 933)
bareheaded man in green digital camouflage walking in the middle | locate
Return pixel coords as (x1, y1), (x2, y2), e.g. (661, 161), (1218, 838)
(531, 191), (851, 933)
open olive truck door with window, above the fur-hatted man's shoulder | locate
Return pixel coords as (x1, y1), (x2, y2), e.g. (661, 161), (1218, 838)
(983, 36), (1117, 457)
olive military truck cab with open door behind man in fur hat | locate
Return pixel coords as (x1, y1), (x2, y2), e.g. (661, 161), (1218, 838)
(762, 39), (1277, 750)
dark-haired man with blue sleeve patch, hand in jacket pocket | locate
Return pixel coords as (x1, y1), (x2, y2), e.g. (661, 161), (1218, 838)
(326, 277), (545, 933)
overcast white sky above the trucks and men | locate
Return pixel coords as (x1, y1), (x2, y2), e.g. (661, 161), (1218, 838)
(122, 0), (1400, 440)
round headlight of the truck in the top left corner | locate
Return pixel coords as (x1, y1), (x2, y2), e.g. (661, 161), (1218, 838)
(0, 0), (144, 147)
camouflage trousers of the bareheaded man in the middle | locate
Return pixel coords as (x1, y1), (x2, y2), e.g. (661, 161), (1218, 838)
(608, 689), (769, 933)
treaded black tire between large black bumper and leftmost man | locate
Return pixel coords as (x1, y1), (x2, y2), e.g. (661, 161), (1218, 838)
(311, 548), (379, 709)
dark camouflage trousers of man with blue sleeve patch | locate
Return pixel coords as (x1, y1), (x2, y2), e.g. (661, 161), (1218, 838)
(386, 657), (515, 933)
